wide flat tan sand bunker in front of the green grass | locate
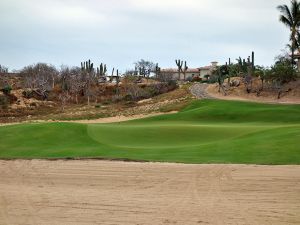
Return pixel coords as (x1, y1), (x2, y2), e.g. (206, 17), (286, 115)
(0, 160), (300, 225)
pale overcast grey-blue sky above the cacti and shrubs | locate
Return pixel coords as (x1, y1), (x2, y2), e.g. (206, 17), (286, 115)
(0, 0), (289, 72)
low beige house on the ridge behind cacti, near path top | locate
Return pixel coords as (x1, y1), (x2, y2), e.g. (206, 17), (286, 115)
(161, 62), (218, 80)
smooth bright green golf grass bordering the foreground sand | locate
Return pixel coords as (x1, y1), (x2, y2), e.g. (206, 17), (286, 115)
(0, 100), (300, 164)
